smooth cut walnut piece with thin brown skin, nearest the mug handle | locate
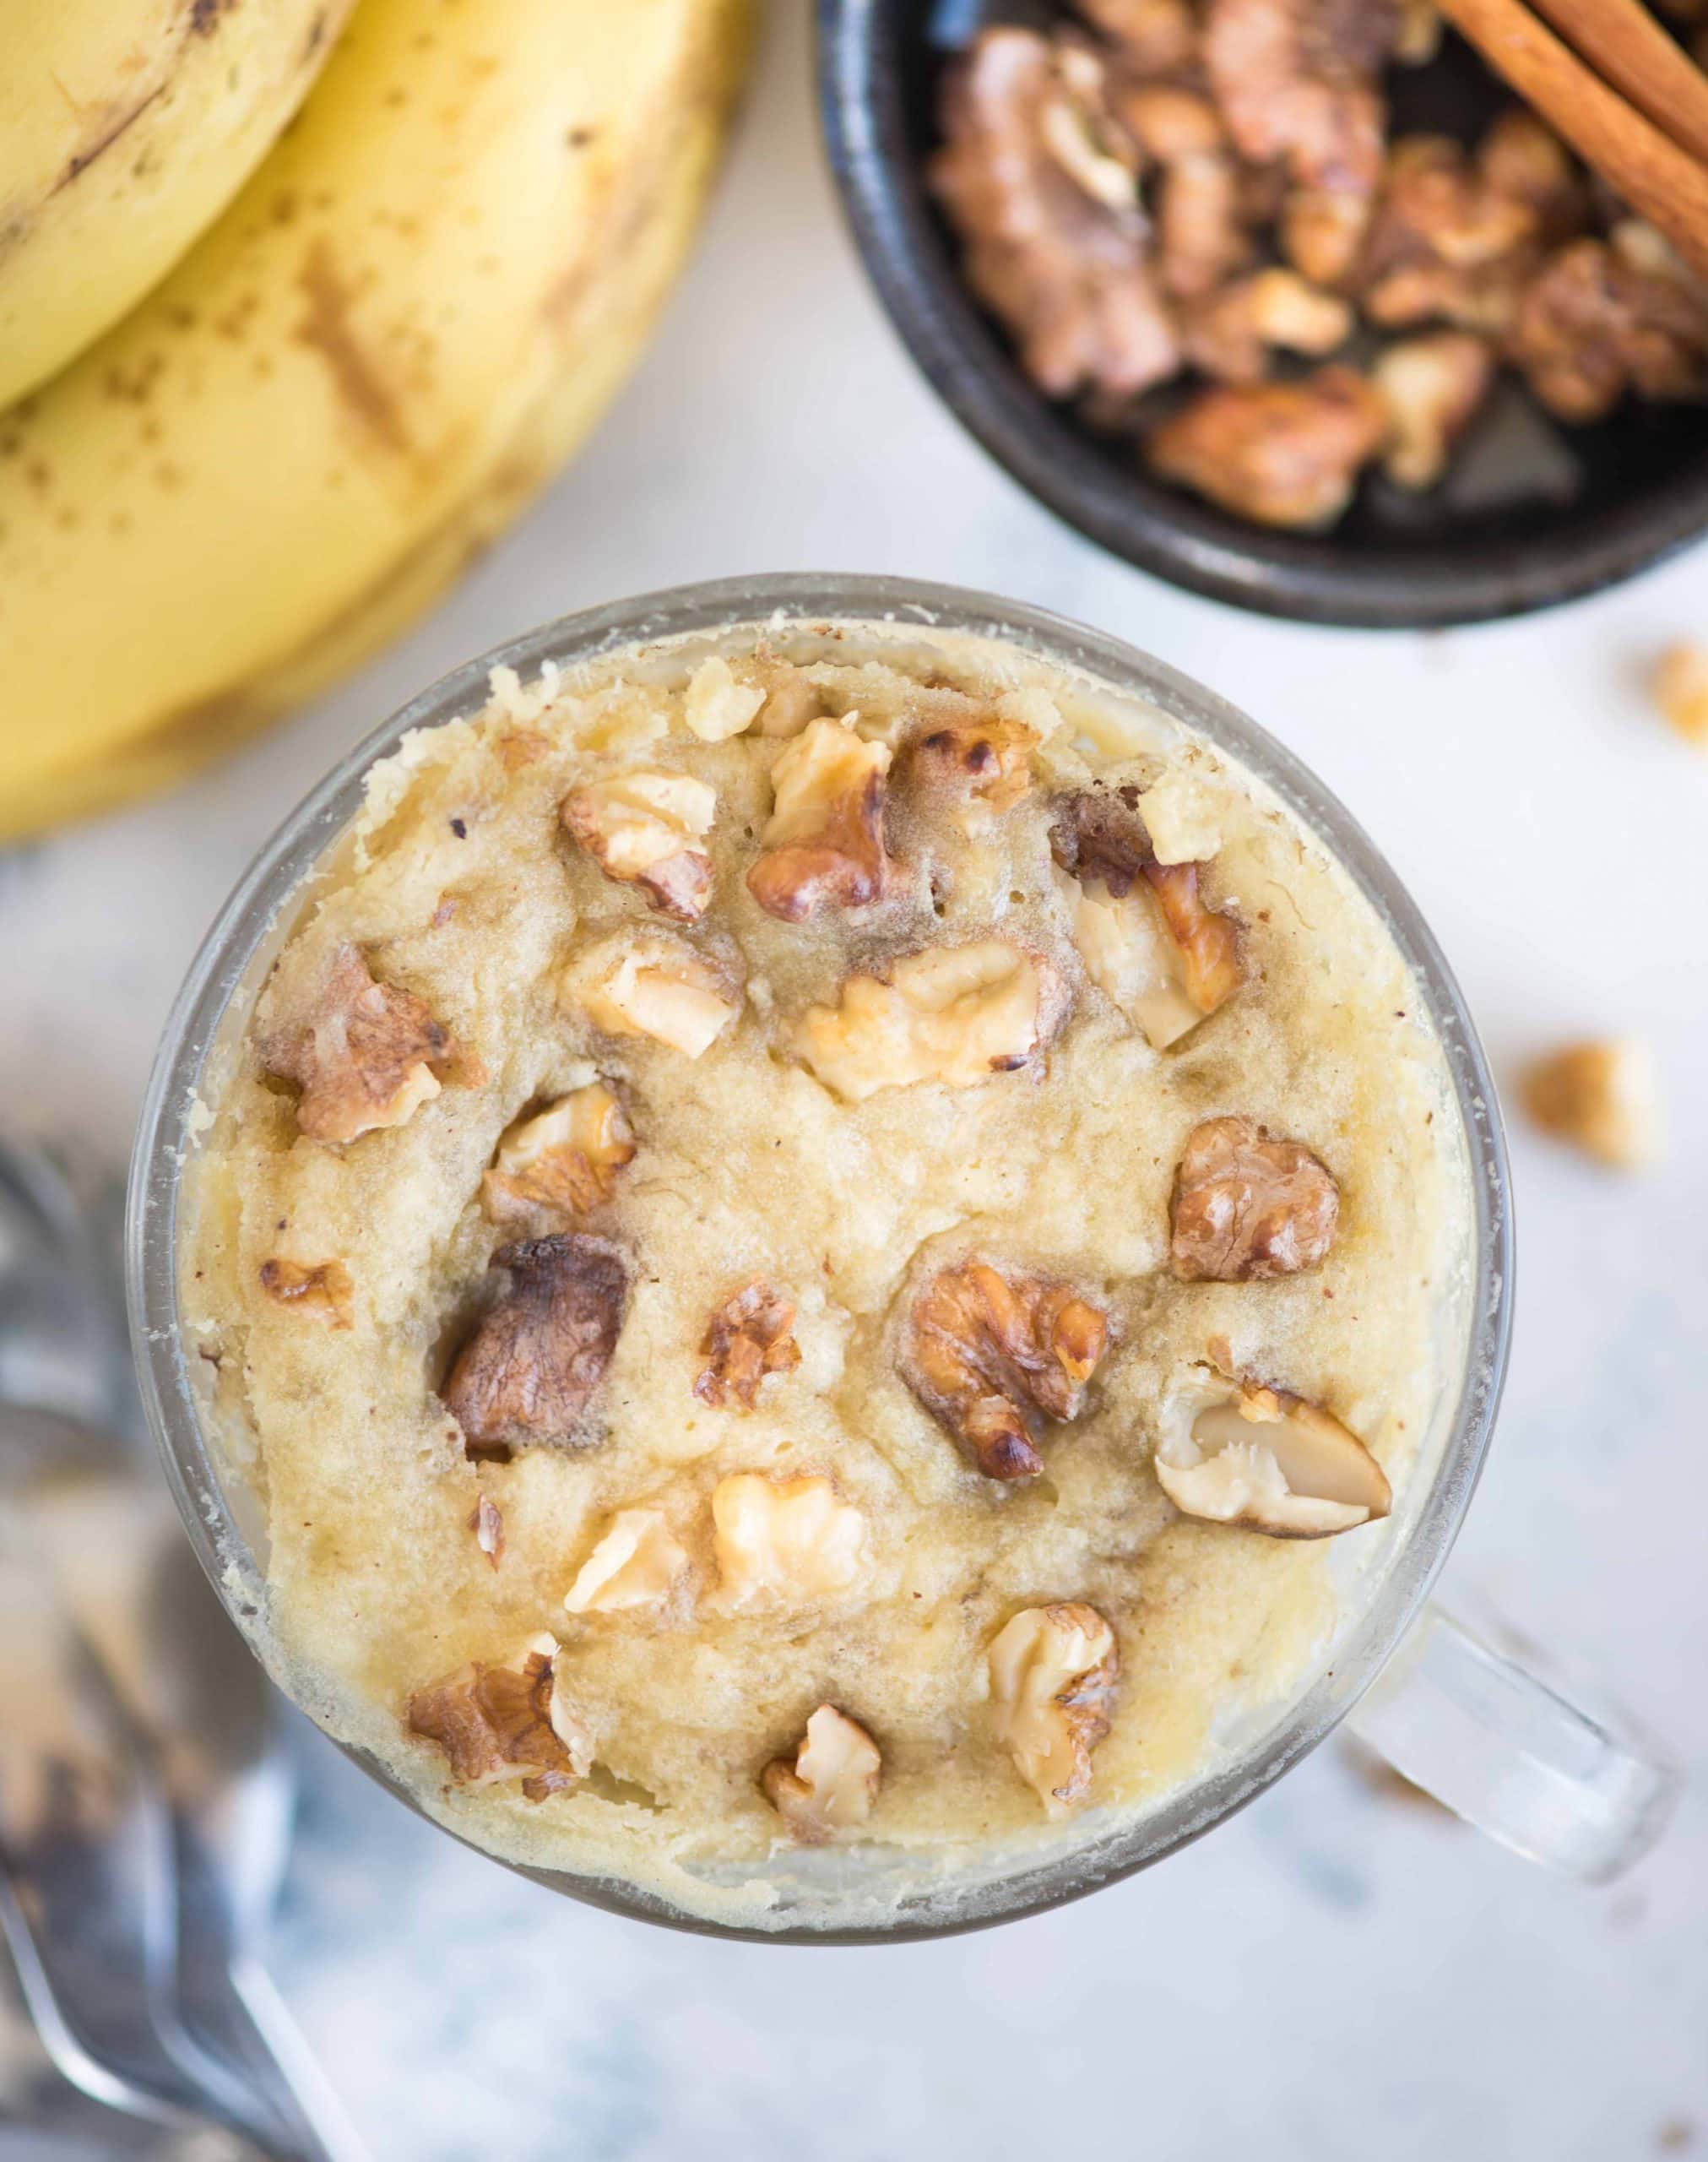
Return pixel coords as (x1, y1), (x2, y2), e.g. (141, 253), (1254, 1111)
(1154, 1366), (1392, 1540)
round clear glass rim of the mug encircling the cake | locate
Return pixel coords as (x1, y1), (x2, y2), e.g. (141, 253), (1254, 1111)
(126, 573), (1514, 1943)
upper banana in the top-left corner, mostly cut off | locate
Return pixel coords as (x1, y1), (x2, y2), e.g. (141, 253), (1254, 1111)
(0, 0), (350, 406)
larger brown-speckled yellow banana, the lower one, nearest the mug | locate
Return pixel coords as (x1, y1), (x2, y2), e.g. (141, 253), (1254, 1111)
(0, 0), (748, 837)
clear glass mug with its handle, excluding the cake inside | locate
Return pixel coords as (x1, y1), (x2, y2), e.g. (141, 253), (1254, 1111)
(127, 575), (1678, 1943)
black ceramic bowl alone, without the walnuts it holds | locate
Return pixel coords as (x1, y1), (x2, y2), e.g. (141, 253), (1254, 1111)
(820, 0), (1708, 629)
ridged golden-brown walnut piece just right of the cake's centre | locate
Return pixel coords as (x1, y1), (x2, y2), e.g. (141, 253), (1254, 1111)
(902, 1260), (1109, 1479)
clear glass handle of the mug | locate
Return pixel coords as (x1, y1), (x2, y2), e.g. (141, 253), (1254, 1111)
(1347, 1606), (1682, 1883)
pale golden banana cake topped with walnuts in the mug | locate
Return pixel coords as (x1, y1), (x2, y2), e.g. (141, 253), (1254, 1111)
(184, 622), (1468, 1926)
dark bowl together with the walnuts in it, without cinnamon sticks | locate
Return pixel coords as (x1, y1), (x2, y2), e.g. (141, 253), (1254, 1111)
(820, 0), (1708, 627)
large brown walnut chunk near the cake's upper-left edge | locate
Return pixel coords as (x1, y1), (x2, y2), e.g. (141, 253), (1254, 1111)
(259, 942), (474, 1142)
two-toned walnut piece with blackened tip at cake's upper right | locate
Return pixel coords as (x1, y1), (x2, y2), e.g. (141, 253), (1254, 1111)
(1051, 789), (1241, 1051)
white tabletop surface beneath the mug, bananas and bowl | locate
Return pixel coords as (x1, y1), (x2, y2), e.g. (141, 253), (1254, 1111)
(0, 8), (1708, 2162)
